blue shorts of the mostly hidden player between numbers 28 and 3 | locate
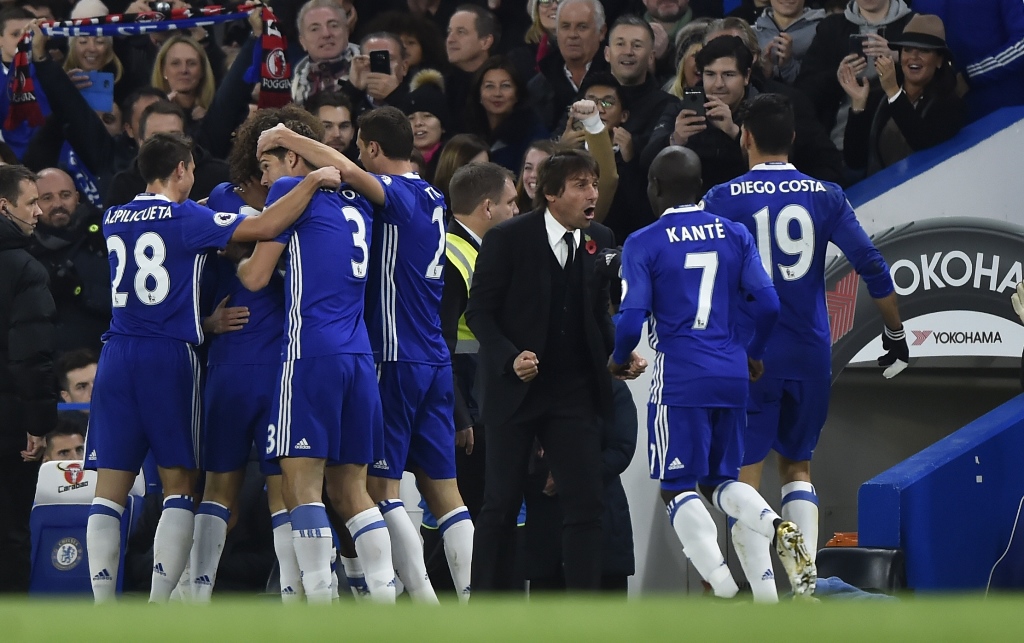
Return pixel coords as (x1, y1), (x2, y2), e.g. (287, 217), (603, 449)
(203, 363), (281, 475)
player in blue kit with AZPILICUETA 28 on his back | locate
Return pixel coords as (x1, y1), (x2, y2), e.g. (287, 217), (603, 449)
(86, 133), (337, 602)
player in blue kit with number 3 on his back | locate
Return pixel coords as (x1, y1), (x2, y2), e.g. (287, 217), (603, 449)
(239, 118), (395, 602)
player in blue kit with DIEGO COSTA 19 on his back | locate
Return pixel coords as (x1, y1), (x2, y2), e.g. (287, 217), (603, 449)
(703, 94), (909, 596)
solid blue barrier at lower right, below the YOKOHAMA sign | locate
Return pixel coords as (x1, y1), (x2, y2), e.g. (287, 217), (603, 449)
(857, 394), (1024, 590)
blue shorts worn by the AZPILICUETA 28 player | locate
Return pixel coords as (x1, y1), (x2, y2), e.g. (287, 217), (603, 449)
(85, 336), (203, 472)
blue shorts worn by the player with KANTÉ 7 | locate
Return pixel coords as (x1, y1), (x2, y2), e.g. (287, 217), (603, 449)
(647, 403), (745, 490)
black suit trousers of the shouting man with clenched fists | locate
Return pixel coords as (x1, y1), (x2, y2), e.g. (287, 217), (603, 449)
(472, 387), (604, 594)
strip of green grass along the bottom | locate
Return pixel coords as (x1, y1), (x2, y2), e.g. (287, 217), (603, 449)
(0, 595), (1024, 643)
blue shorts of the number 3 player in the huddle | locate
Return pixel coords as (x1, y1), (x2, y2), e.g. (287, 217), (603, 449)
(265, 353), (384, 465)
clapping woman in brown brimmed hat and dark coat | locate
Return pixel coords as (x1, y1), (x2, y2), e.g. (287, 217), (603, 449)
(839, 13), (967, 174)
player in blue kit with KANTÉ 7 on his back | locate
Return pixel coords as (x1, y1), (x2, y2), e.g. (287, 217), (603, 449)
(608, 146), (815, 598)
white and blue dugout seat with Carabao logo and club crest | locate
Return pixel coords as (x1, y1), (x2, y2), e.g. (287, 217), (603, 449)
(29, 460), (145, 595)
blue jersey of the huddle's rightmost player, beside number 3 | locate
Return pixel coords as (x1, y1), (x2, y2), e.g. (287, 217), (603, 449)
(367, 173), (451, 366)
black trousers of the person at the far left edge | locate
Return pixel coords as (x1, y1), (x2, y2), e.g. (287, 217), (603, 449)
(0, 444), (39, 593)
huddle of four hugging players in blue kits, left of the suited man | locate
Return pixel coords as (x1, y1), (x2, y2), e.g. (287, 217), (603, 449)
(86, 104), (473, 603)
